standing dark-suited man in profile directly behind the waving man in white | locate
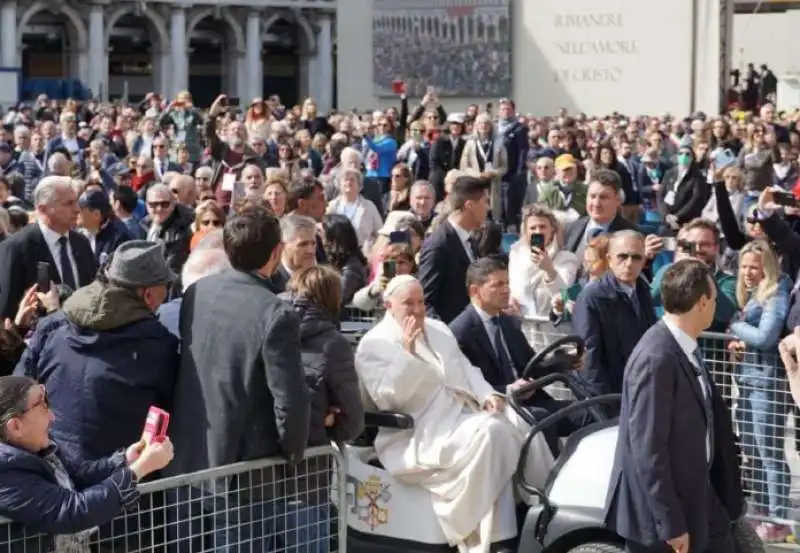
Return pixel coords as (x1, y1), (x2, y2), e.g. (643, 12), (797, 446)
(418, 176), (489, 323)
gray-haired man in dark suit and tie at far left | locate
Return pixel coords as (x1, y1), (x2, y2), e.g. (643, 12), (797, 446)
(0, 175), (97, 319)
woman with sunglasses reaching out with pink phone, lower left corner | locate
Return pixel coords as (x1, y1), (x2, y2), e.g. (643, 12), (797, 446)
(0, 376), (173, 551)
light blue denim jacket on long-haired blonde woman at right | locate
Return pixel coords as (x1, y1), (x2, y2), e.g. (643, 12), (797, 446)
(731, 275), (792, 388)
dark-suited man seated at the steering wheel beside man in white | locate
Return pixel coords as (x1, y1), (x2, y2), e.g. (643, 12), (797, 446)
(450, 257), (583, 455)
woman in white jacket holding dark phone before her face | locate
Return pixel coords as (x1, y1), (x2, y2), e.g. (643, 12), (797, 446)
(508, 204), (580, 351)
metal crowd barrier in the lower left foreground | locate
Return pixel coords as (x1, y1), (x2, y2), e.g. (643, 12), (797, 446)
(0, 446), (347, 553)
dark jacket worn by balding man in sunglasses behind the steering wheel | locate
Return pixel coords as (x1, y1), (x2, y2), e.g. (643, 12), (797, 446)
(572, 272), (660, 396)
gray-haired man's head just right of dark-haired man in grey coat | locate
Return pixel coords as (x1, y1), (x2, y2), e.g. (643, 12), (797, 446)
(270, 214), (317, 294)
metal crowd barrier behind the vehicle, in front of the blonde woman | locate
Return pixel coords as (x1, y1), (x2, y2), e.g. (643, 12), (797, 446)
(523, 317), (800, 541)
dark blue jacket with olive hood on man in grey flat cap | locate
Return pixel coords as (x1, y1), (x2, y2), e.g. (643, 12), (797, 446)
(15, 281), (178, 459)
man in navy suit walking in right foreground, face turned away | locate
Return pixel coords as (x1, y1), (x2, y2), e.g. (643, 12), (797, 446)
(605, 259), (743, 553)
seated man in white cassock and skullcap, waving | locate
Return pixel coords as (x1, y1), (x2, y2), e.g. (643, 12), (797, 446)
(356, 275), (553, 553)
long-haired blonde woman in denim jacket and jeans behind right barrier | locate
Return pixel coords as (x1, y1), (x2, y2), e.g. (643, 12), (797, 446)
(728, 240), (792, 543)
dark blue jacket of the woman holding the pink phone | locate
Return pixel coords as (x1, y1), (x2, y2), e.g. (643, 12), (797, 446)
(0, 443), (139, 540)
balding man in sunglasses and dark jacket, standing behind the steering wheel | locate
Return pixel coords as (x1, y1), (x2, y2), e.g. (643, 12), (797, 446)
(572, 230), (656, 402)
